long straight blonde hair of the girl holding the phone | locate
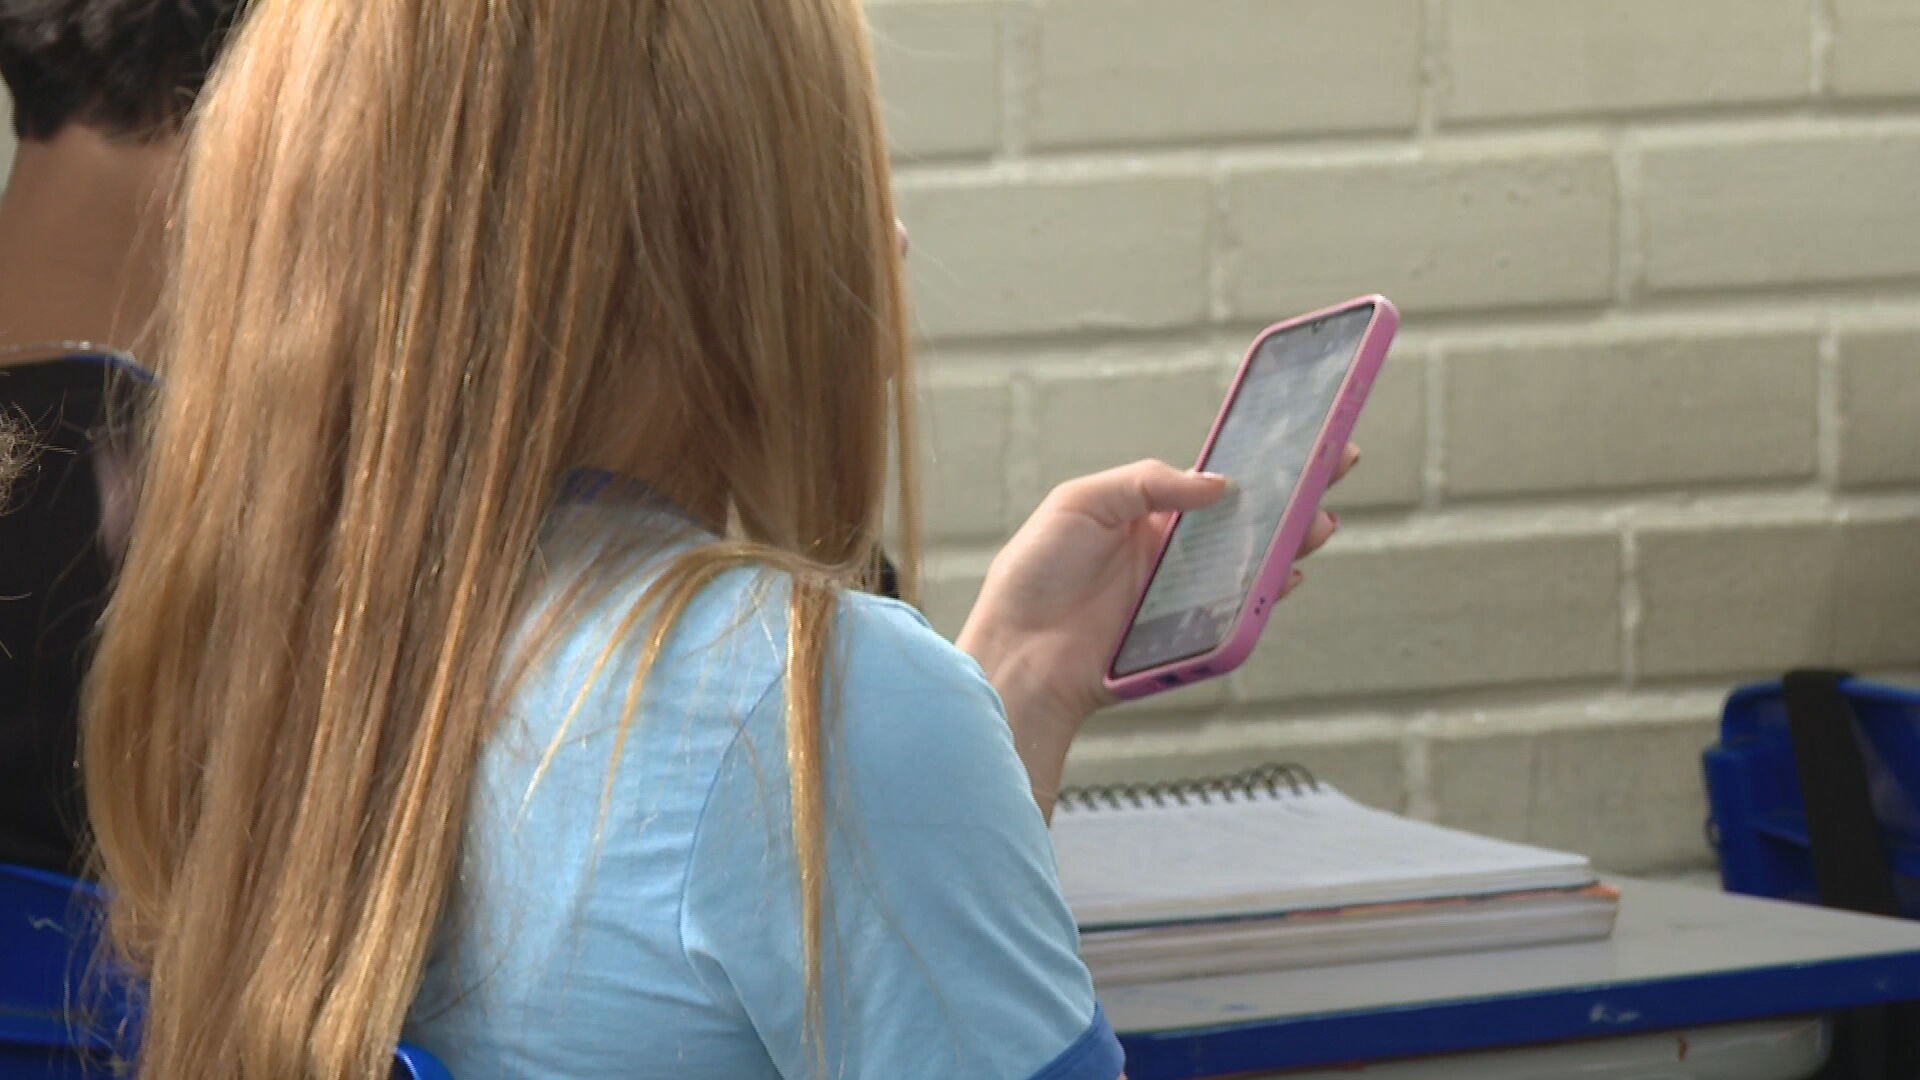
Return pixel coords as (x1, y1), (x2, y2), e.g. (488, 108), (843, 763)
(83, 0), (918, 1080)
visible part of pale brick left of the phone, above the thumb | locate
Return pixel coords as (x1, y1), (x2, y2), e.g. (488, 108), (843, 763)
(1033, 359), (1225, 488)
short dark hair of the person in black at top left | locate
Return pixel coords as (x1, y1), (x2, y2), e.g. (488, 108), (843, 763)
(0, 0), (244, 138)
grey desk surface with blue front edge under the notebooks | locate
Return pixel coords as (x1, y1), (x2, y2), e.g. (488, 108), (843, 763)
(1102, 880), (1920, 1078)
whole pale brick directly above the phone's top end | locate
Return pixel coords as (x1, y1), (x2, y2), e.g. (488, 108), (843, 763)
(1229, 144), (1615, 319)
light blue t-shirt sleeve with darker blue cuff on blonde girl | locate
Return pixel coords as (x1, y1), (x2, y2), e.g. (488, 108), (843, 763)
(682, 596), (1121, 1080)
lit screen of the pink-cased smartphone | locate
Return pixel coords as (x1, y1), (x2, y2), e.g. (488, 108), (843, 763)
(1114, 304), (1375, 675)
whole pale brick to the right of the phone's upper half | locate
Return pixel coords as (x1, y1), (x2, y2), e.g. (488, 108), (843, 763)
(1446, 334), (1820, 496)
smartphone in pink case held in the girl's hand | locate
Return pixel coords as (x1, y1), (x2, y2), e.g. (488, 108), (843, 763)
(1106, 296), (1400, 698)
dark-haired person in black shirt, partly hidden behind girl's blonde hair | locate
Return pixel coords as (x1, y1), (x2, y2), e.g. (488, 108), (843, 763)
(0, 0), (240, 871)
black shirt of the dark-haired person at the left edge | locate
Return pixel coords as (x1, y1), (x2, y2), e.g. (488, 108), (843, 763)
(0, 357), (125, 872)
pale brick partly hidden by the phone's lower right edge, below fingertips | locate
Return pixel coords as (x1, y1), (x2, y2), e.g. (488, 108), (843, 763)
(1236, 536), (1620, 698)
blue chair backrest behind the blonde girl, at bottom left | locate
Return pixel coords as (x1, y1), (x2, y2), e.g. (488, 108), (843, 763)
(0, 863), (453, 1080)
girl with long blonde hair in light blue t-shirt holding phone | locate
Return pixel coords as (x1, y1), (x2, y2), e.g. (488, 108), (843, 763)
(83, 0), (1327, 1080)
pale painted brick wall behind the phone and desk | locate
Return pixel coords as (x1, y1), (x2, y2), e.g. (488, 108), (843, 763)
(870, 0), (1920, 871)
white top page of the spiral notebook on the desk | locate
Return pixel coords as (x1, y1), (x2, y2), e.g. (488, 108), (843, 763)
(1052, 786), (1594, 930)
